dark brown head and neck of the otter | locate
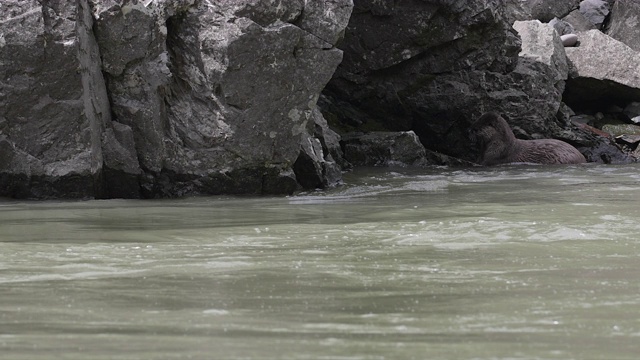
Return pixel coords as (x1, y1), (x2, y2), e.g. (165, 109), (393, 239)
(469, 112), (516, 165)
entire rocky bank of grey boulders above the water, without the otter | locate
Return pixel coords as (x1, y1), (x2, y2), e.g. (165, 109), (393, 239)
(0, 0), (640, 199)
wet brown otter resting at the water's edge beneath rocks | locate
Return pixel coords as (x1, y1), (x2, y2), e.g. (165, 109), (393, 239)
(469, 112), (586, 166)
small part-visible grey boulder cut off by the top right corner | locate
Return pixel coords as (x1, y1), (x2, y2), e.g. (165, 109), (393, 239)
(607, 0), (640, 51)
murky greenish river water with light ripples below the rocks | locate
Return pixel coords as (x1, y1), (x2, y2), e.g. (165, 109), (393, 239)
(0, 165), (640, 360)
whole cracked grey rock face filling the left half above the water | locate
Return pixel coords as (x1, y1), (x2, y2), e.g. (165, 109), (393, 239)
(0, 0), (352, 198)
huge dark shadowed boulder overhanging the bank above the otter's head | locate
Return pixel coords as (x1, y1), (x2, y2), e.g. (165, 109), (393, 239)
(322, 0), (520, 160)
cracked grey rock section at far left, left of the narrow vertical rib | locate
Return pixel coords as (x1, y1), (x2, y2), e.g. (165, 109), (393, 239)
(0, 0), (95, 198)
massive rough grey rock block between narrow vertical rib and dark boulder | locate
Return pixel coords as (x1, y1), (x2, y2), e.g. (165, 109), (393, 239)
(96, 0), (351, 196)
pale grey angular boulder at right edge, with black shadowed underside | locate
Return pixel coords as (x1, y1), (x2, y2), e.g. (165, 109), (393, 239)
(565, 30), (640, 109)
